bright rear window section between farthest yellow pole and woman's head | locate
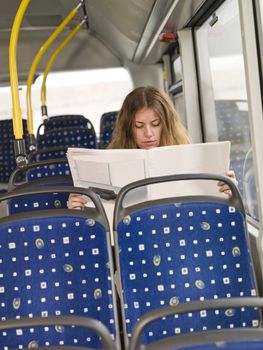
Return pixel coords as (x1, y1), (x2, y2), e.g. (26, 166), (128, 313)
(36, 68), (132, 135)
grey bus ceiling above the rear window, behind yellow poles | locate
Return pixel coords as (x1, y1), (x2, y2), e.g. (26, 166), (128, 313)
(0, 0), (209, 84)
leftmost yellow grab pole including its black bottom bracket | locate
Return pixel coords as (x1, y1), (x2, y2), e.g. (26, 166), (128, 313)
(9, 0), (30, 167)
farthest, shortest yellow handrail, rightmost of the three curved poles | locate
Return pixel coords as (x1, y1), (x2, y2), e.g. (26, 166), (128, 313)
(41, 20), (86, 119)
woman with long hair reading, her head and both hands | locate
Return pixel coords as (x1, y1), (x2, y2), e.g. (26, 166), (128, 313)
(68, 86), (236, 209)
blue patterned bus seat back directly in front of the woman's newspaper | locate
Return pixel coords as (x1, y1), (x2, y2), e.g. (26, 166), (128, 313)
(114, 174), (260, 345)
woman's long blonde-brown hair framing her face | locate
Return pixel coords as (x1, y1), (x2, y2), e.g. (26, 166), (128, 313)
(108, 86), (191, 149)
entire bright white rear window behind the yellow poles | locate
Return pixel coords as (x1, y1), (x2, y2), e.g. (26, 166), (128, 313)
(0, 68), (133, 134)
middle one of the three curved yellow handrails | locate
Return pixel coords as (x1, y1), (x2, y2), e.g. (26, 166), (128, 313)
(26, 2), (82, 134)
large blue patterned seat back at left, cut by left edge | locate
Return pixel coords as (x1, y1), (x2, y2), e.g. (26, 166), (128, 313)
(0, 187), (119, 350)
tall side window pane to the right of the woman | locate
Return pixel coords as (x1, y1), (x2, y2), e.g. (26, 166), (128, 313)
(196, 0), (258, 218)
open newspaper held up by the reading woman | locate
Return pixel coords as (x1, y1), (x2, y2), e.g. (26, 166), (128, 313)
(67, 141), (230, 199)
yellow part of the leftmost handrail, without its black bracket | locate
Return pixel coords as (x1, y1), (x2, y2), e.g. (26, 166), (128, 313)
(9, 0), (31, 139)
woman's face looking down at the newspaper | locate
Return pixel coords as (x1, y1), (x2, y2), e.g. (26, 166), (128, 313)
(133, 108), (162, 149)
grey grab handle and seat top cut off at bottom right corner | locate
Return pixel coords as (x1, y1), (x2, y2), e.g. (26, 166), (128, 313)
(129, 298), (263, 350)
